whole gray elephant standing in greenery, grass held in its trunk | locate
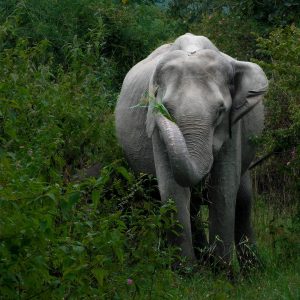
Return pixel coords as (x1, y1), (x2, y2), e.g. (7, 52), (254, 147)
(115, 33), (268, 263)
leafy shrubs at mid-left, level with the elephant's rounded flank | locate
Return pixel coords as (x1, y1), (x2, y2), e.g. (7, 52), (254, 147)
(0, 39), (116, 181)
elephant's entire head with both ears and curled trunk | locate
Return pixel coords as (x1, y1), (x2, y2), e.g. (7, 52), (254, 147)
(146, 49), (268, 186)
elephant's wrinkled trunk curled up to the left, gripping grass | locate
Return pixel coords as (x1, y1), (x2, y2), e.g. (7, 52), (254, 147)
(156, 115), (213, 186)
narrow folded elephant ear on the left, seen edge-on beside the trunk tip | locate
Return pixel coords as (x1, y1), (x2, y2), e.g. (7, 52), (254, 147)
(146, 72), (158, 138)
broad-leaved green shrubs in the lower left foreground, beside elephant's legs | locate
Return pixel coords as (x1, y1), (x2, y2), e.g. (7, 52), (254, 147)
(0, 163), (182, 299)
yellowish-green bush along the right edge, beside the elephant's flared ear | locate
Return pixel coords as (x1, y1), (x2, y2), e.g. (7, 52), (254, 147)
(253, 26), (300, 201)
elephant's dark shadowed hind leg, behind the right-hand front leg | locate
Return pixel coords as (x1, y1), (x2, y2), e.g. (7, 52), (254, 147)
(235, 171), (260, 270)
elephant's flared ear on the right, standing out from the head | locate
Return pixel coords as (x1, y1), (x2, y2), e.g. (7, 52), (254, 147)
(231, 61), (268, 125)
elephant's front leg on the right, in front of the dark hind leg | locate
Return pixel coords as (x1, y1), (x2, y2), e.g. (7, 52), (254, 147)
(209, 132), (241, 268)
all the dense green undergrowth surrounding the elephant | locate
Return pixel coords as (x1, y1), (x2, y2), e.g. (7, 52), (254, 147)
(0, 0), (300, 299)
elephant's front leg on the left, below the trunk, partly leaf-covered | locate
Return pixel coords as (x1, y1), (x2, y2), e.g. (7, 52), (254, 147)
(152, 130), (195, 261)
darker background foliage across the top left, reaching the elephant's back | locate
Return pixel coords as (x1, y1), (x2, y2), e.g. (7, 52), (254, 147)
(0, 0), (182, 84)
